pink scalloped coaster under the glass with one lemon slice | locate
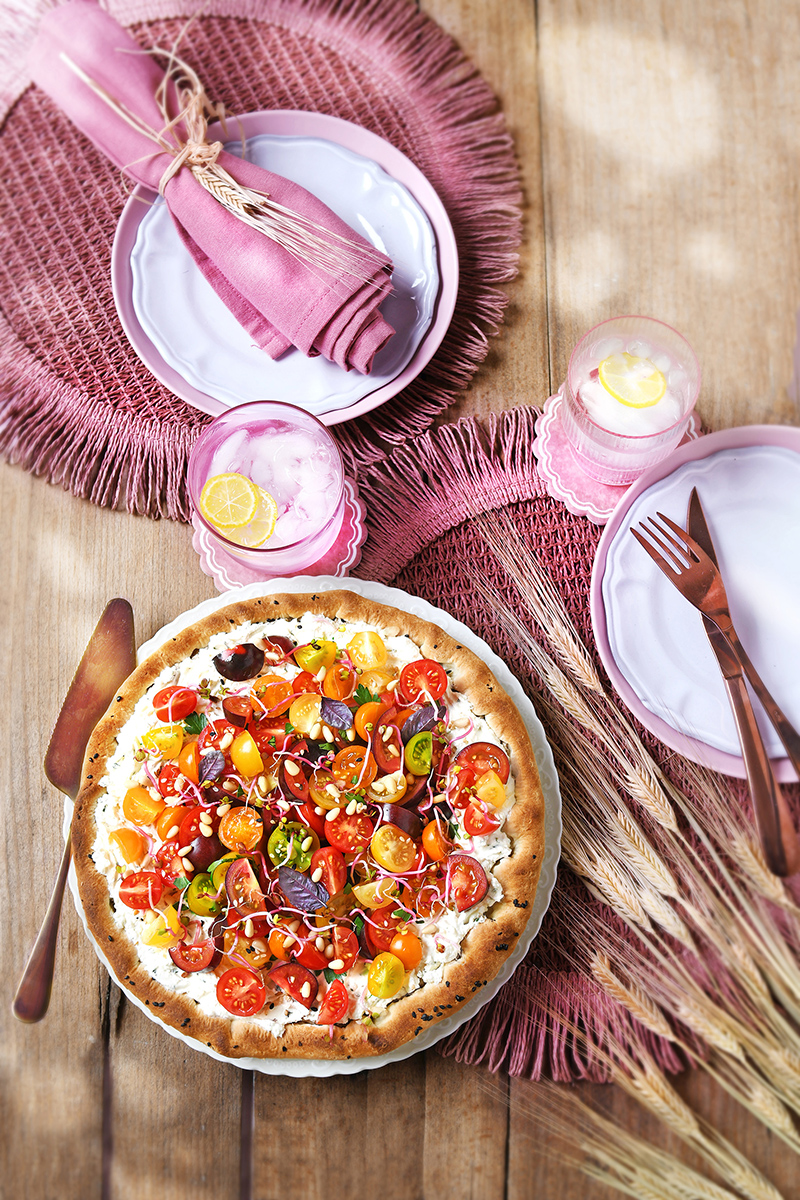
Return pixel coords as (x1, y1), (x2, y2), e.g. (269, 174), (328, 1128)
(534, 384), (703, 524)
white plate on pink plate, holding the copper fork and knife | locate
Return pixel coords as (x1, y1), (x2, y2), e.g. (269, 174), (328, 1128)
(591, 426), (800, 780)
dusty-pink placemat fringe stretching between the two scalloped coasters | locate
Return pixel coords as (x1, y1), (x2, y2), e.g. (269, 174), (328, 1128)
(354, 406), (546, 583)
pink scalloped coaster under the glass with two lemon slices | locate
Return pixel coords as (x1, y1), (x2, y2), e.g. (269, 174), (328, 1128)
(192, 479), (367, 592)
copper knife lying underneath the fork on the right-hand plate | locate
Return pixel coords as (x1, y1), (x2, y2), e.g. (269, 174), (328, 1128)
(686, 487), (800, 876)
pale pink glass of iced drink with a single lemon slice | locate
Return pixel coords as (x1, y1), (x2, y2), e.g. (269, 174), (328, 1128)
(560, 317), (700, 486)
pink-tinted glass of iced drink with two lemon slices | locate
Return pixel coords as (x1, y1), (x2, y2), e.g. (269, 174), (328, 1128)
(187, 400), (344, 576)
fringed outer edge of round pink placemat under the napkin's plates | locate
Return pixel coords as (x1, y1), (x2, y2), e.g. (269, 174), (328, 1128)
(0, 0), (522, 511)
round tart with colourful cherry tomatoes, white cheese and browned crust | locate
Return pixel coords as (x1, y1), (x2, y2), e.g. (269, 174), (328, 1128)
(72, 581), (558, 1069)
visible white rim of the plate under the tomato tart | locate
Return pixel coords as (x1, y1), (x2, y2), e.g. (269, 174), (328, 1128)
(65, 575), (561, 1078)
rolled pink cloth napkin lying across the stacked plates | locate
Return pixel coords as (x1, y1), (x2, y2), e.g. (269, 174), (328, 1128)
(30, 0), (393, 373)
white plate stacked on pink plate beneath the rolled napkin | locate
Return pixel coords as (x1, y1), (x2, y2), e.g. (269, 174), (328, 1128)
(112, 112), (458, 425)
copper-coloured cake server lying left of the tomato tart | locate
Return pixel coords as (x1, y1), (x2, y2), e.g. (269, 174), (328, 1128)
(12, 599), (136, 1021)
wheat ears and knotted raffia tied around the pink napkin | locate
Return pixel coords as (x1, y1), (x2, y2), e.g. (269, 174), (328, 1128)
(60, 47), (391, 283)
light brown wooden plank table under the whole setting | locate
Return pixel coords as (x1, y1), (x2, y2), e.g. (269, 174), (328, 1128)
(6, 0), (800, 1200)
